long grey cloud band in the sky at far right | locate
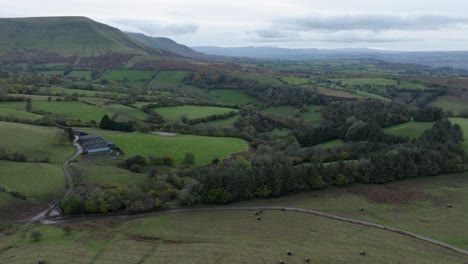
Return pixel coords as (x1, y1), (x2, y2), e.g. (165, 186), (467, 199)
(271, 13), (468, 31)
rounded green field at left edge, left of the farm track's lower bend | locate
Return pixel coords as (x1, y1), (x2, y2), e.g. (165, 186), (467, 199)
(0, 161), (65, 203)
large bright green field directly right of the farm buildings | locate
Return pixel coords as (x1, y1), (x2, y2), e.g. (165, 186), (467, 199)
(76, 129), (248, 164)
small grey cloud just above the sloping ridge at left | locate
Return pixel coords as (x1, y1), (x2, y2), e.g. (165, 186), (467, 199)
(112, 19), (198, 36)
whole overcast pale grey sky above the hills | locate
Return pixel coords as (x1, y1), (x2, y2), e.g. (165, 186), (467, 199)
(0, 0), (468, 50)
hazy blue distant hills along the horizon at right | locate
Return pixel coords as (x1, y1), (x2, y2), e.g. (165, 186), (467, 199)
(192, 46), (468, 70)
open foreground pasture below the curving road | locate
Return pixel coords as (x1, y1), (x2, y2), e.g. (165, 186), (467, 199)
(0, 211), (467, 264)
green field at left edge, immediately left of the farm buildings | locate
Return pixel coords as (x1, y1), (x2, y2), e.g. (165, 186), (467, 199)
(0, 122), (74, 164)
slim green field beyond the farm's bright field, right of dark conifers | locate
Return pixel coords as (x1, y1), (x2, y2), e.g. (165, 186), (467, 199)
(154, 105), (239, 120)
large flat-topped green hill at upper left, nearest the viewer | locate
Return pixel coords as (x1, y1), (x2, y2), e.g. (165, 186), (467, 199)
(0, 17), (174, 59)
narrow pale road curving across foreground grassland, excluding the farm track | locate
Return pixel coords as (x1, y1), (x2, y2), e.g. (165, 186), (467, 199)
(41, 206), (468, 256)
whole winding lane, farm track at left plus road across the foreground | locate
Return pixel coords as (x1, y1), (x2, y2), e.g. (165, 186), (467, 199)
(24, 136), (468, 256)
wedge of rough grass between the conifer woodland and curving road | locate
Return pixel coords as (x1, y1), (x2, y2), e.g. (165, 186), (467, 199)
(234, 173), (468, 249)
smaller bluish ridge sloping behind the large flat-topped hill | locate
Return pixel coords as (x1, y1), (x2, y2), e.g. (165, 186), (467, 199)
(127, 32), (209, 59)
